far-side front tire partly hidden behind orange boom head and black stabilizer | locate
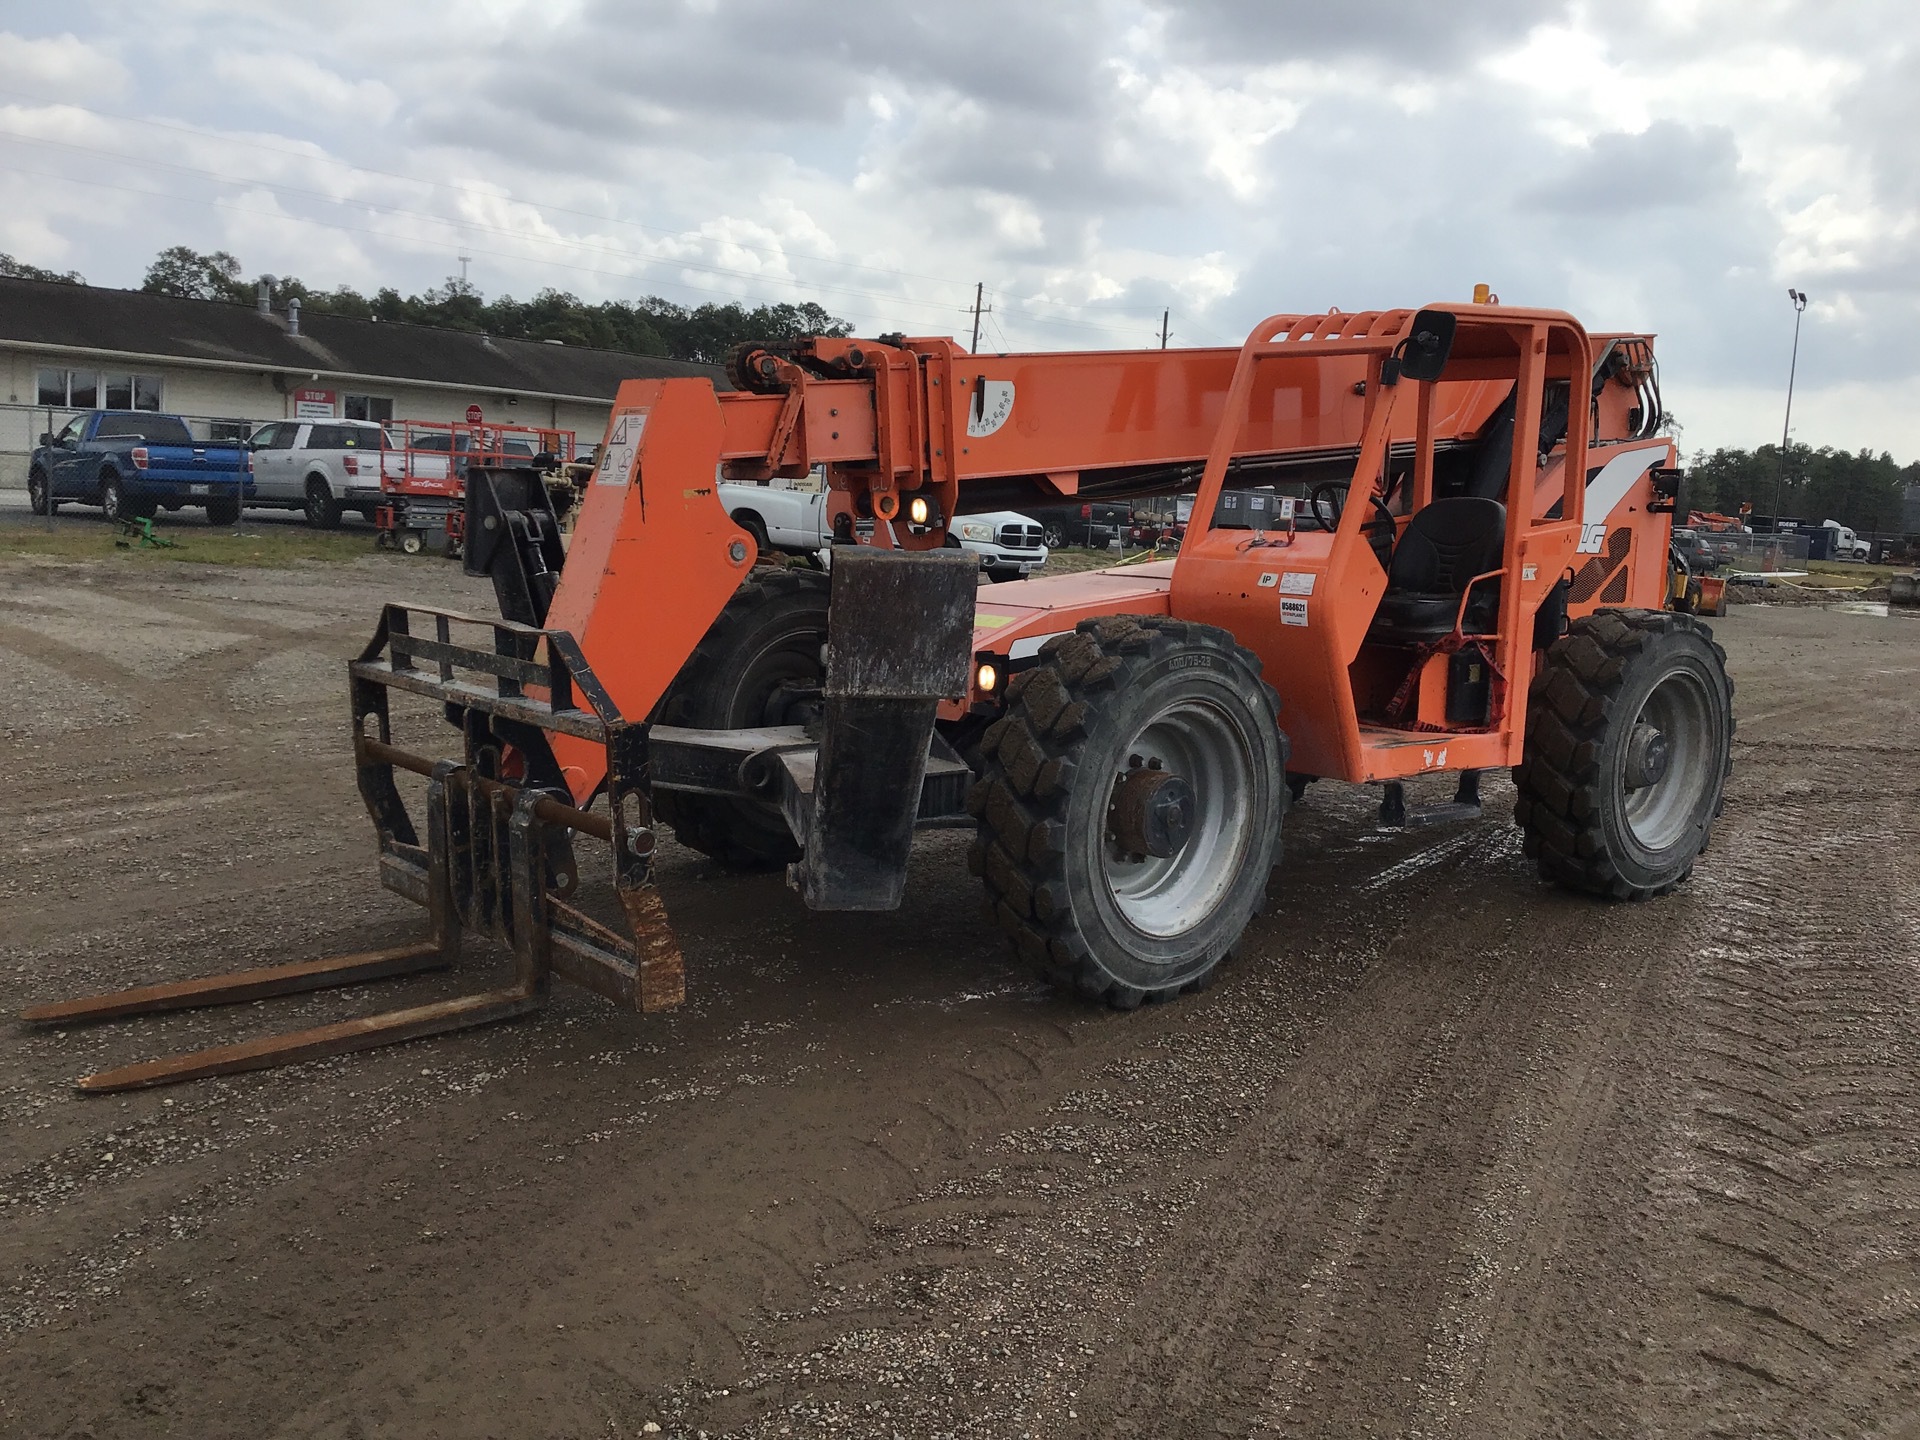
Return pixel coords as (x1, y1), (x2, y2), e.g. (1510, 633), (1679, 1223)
(653, 568), (828, 870)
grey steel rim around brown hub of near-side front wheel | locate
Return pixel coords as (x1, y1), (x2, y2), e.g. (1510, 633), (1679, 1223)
(1096, 701), (1254, 939)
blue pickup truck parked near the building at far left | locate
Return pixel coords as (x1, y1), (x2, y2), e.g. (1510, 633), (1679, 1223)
(27, 411), (253, 524)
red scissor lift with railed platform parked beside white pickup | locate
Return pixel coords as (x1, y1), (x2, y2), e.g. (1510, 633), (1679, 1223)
(372, 420), (574, 557)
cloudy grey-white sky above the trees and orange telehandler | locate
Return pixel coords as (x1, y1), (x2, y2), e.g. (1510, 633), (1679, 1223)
(0, 0), (1920, 463)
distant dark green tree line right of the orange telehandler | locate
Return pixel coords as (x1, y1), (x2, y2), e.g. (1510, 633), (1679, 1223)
(1688, 442), (1920, 534)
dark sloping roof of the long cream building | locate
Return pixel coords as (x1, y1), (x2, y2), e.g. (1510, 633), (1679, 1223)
(0, 276), (724, 399)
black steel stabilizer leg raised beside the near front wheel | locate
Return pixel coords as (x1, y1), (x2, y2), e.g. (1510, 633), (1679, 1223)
(781, 545), (979, 910)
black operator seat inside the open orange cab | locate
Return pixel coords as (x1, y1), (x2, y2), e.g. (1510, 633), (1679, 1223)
(1367, 495), (1507, 645)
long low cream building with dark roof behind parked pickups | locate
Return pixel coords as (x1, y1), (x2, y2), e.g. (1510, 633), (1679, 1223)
(0, 278), (718, 488)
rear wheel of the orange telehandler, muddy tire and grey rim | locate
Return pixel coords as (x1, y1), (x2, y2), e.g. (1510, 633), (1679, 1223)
(1513, 611), (1734, 900)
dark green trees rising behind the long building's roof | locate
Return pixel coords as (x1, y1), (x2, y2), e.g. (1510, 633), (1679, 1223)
(131, 246), (852, 365)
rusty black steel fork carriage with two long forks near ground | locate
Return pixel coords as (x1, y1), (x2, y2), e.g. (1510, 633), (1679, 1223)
(21, 605), (685, 1094)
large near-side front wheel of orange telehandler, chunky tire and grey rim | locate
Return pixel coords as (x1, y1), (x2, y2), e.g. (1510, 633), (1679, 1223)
(968, 616), (1288, 1010)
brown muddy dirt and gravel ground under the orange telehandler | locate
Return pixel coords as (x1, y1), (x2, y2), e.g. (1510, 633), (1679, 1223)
(0, 526), (1920, 1440)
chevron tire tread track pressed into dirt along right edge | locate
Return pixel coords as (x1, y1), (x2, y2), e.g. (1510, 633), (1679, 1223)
(1674, 779), (1920, 1436)
